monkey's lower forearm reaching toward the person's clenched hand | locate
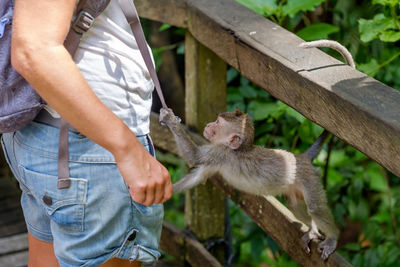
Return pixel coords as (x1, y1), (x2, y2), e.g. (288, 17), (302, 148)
(172, 166), (214, 193)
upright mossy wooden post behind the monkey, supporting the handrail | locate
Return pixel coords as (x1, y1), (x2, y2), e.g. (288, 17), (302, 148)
(185, 32), (226, 262)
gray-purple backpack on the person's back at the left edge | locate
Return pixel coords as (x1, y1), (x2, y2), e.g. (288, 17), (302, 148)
(0, 0), (110, 133)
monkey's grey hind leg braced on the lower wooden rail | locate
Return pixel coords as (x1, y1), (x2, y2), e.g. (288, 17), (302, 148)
(302, 174), (339, 260)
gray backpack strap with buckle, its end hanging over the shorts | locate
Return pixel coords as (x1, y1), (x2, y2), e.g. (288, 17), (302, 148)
(57, 0), (110, 189)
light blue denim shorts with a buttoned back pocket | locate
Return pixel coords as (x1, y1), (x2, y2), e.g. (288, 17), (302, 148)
(1, 122), (164, 266)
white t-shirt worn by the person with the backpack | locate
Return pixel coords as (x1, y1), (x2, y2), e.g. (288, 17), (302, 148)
(46, 0), (154, 135)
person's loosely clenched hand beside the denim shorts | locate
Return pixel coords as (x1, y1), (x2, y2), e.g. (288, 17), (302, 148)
(115, 141), (172, 206)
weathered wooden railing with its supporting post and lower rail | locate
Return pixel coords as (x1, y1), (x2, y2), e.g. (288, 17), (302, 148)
(135, 0), (400, 266)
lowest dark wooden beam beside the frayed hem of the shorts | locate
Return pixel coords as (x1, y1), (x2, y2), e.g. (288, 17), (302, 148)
(160, 221), (222, 267)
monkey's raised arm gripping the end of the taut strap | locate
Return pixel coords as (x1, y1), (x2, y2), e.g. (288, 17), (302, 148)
(160, 108), (199, 167)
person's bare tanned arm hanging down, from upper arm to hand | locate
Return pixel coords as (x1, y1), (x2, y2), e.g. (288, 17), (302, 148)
(11, 0), (172, 205)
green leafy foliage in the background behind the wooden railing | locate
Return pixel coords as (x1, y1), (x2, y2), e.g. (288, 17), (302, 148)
(159, 0), (400, 267)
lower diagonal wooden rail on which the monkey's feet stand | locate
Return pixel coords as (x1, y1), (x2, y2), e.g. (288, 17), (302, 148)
(151, 114), (351, 266)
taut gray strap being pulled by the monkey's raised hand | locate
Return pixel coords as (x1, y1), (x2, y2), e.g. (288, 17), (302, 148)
(119, 0), (167, 108)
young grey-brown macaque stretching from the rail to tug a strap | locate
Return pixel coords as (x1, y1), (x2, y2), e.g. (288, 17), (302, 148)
(160, 40), (354, 260)
